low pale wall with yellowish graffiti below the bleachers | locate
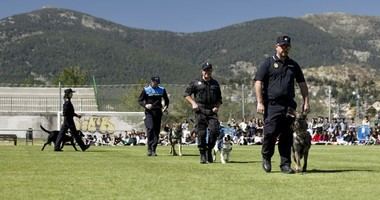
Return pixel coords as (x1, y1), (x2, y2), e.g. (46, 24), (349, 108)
(0, 112), (144, 138)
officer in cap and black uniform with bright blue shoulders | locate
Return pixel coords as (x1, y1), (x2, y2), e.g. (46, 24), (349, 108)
(138, 76), (169, 156)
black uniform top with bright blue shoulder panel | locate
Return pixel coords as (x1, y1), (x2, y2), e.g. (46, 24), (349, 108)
(138, 86), (169, 109)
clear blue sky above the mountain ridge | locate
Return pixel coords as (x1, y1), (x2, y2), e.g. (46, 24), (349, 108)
(0, 0), (380, 33)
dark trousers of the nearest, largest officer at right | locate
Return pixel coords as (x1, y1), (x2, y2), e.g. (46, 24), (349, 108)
(261, 101), (293, 167)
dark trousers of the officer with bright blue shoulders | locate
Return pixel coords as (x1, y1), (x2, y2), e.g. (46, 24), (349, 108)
(144, 109), (162, 152)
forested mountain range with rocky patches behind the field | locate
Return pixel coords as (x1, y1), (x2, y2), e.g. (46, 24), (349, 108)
(0, 8), (380, 84)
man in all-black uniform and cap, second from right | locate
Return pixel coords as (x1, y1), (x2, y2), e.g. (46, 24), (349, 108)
(184, 63), (222, 164)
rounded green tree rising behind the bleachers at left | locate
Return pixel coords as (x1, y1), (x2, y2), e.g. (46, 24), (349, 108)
(53, 66), (88, 85)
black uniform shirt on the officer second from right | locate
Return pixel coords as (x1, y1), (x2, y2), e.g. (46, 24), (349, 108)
(184, 78), (222, 108)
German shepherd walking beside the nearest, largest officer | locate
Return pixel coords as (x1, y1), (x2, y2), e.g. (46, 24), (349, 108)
(292, 114), (311, 173)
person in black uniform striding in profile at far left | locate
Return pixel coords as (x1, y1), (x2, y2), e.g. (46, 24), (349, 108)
(54, 88), (90, 151)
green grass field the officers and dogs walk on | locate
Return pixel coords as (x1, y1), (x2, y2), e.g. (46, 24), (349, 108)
(0, 143), (380, 200)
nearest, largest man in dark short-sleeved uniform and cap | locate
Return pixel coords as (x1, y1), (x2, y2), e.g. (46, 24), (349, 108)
(254, 35), (310, 174)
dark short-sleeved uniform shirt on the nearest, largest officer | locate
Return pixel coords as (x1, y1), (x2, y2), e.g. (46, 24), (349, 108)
(254, 55), (305, 100)
